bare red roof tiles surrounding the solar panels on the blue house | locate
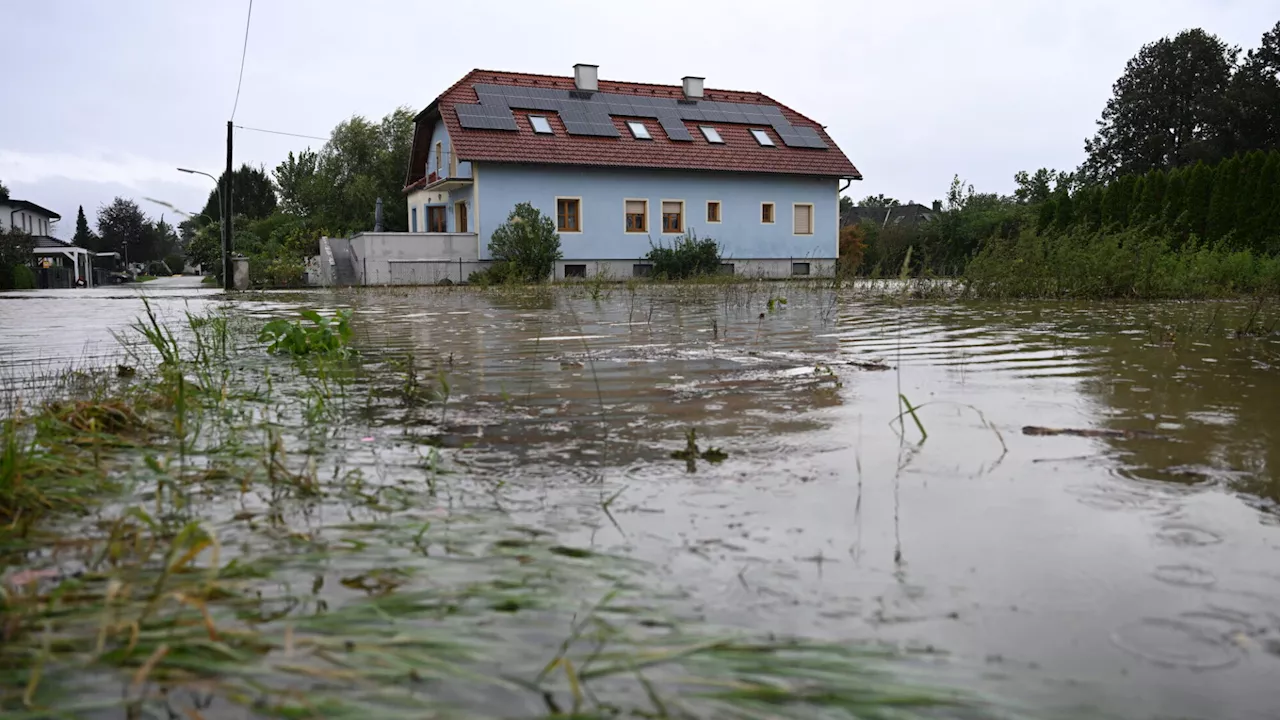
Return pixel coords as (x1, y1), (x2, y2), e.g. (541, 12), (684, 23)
(406, 70), (861, 190)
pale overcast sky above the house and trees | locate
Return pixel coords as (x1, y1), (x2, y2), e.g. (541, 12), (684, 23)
(0, 0), (1280, 236)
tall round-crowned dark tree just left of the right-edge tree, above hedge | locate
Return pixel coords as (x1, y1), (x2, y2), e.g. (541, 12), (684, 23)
(1082, 29), (1239, 179)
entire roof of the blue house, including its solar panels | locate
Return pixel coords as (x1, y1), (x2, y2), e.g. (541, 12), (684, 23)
(406, 70), (861, 190)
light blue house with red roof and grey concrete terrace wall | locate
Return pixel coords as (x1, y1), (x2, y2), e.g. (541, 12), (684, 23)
(329, 65), (861, 284)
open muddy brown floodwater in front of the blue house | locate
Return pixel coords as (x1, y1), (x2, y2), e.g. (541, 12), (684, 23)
(0, 279), (1280, 717)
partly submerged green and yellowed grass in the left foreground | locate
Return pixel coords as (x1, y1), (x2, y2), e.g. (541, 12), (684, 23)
(0, 295), (982, 719)
